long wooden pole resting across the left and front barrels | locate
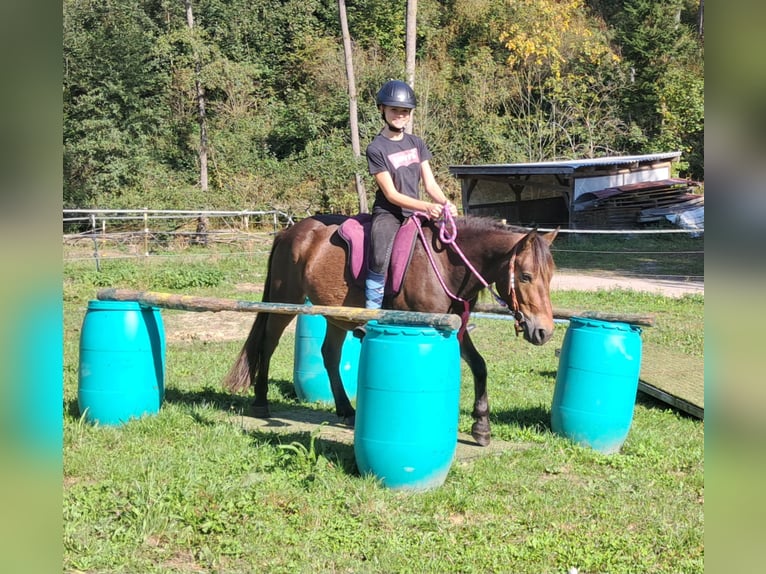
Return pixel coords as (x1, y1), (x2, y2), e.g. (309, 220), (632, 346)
(96, 287), (460, 331)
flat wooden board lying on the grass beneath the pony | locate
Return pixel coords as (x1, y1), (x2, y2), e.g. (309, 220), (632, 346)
(236, 406), (531, 461)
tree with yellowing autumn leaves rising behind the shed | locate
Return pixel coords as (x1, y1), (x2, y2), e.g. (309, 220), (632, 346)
(500, 0), (625, 161)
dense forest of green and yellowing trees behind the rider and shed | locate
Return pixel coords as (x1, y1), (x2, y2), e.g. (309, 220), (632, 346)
(63, 0), (704, 214)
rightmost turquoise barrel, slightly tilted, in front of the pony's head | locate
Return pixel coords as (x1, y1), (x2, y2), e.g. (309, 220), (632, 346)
(551, 317), (641, 454)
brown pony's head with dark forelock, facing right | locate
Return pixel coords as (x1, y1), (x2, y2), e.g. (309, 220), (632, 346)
(495, 228), (558, 345)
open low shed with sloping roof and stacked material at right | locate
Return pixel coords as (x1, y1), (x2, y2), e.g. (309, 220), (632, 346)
(449, 152), (701, 229)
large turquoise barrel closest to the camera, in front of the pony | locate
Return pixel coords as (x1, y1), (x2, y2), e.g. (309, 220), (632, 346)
(354, 321), (460, 490)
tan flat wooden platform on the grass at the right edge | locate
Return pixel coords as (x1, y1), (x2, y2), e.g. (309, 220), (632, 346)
(638, 344), (705, 419)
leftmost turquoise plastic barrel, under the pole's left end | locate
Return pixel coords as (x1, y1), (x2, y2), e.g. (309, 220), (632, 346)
(77, 301), (165, 425)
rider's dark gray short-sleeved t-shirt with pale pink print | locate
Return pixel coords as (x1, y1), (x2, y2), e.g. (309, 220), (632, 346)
(366, 134), (432, 217)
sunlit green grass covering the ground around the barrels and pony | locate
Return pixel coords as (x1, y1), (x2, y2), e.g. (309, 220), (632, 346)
(64, 241), (704, 574)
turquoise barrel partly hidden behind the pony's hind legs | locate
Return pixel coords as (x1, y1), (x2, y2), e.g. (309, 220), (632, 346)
(293, 315), (362, 403)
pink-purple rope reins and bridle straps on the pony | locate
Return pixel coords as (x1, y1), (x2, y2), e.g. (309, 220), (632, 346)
(412, 213), (526, 341)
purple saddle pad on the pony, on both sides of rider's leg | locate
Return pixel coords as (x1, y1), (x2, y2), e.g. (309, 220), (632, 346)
(336, 213), (418, 296)
